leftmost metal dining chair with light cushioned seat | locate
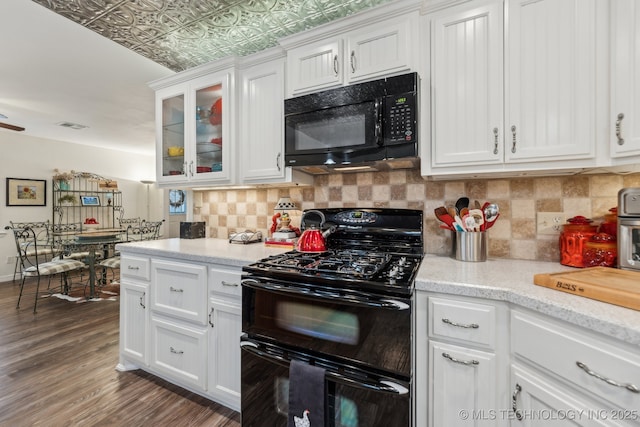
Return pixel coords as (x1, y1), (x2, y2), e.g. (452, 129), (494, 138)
(5, 227), (85, 313)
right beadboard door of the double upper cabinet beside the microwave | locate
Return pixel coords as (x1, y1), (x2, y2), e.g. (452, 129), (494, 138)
(505, 0), (597, 162)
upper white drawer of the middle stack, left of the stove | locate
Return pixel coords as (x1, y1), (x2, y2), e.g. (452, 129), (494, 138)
(150, 259), (207, 325)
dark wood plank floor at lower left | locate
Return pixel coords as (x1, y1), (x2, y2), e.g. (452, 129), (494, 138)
(0, 276), (240, 427)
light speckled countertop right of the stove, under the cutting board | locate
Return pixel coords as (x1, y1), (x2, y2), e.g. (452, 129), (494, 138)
(415, 255), (640, 345)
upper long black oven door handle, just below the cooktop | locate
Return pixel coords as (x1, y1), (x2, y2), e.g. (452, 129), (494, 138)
(242, 279), (411, 310)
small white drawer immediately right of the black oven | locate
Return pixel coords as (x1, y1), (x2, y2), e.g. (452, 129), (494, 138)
(428, 297), (496, 349)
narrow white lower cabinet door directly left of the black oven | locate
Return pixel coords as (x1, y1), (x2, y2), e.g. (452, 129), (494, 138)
(208, 299), (242, 411)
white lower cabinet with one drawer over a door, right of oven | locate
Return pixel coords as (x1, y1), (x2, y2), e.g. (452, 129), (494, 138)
(414, 292), (508, 427)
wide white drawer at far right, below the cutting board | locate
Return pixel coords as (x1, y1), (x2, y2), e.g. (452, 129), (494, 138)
(511, 310), (640, 408)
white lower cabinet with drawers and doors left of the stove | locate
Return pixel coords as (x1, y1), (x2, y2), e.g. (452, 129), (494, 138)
(118, 250), (242, 411)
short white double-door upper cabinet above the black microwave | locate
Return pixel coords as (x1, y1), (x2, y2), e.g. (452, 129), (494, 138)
(281, 1), (419, 97)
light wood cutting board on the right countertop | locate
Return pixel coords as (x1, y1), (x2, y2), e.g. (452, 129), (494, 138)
(533, 267), (640, 310)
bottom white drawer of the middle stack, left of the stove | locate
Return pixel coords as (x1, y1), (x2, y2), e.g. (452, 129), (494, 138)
(151, 318), (207, 390)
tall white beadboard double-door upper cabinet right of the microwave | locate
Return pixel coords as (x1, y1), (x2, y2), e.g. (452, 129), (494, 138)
(422, 0), (597, 177)
